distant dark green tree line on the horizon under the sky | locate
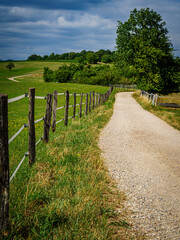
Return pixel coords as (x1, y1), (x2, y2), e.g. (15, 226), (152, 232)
(27, 49), (115, 64)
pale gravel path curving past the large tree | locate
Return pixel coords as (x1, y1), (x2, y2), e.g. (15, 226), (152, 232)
(99, 93), (180, 240)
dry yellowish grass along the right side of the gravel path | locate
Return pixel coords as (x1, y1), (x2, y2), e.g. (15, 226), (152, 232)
(133, 91), (180, 130)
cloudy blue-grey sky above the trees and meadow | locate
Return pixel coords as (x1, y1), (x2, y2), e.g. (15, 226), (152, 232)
(0, 0), (180, 60)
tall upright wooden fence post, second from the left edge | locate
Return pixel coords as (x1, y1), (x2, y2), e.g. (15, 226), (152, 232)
(28, 88), (36, 165)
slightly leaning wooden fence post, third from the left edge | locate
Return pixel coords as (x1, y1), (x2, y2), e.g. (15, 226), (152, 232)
(43, 94), (52, 142)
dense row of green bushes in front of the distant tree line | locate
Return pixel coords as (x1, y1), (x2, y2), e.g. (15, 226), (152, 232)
(44, 64), (135, 86)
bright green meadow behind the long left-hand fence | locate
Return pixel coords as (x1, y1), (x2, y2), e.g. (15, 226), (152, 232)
(0, 62), (108, 189)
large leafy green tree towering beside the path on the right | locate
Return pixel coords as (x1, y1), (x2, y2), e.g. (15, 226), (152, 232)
(116, 8), (179, 93)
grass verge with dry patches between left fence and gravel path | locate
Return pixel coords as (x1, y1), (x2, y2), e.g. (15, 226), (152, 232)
(6, 93), (144, 240)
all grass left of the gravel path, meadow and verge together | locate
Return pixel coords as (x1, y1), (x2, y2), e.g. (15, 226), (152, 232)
(0, 62), (144, 240)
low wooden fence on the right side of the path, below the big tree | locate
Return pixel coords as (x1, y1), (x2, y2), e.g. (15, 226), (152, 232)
(141, 90), (180, 108)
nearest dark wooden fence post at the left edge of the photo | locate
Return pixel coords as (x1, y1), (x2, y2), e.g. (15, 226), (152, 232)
(0, 93), (9, 235)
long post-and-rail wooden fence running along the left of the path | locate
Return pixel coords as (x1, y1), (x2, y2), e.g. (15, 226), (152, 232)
(0, 87), (113, 233)
